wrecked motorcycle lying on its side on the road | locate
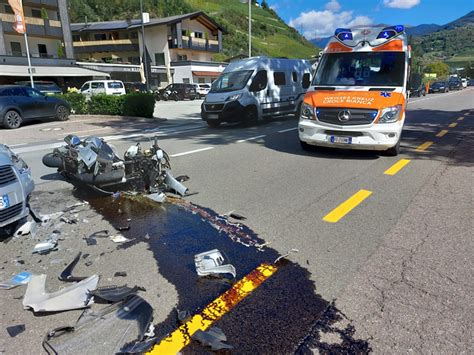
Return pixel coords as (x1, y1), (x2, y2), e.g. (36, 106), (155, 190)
(43, 135), (187, 195)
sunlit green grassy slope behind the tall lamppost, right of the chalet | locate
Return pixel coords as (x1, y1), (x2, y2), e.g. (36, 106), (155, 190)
(186, 0), (318, 60)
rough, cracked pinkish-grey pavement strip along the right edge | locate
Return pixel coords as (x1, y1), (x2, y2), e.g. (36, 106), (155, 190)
(336, 136), (474, 354)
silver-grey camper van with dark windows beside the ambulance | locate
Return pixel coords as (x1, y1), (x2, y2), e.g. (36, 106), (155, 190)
(201, 57), (311, 127)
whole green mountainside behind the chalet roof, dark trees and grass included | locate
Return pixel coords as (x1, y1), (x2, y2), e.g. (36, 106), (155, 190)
(69, 0), (319, 60)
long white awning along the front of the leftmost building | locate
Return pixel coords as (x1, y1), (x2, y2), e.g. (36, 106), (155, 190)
(0, 65), (110, 77)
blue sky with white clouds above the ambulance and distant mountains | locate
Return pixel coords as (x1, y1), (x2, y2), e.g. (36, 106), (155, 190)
(267, 0), (474, 39)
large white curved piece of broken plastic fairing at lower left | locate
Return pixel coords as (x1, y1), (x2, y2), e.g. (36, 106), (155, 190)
(23, 275), (99, 312)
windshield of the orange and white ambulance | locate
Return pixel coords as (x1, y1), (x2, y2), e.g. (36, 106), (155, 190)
(313, 52), (405, 86)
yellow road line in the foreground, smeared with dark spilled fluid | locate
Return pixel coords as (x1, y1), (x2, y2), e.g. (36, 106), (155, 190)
(148, 264), (278, 355)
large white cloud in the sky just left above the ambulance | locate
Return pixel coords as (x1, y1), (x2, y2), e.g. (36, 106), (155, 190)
(289, 0), (372, 39)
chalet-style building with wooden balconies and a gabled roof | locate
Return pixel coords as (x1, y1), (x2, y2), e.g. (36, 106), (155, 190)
(71, 11), (227, 88)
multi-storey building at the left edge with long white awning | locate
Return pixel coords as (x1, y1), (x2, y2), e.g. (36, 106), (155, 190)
(0, 0), (108, 88)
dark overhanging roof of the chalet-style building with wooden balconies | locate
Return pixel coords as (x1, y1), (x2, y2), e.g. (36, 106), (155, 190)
(71, 11), (227, 33)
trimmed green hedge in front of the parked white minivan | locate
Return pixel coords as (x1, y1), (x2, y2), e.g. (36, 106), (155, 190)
(57, 92), (155, 118)
